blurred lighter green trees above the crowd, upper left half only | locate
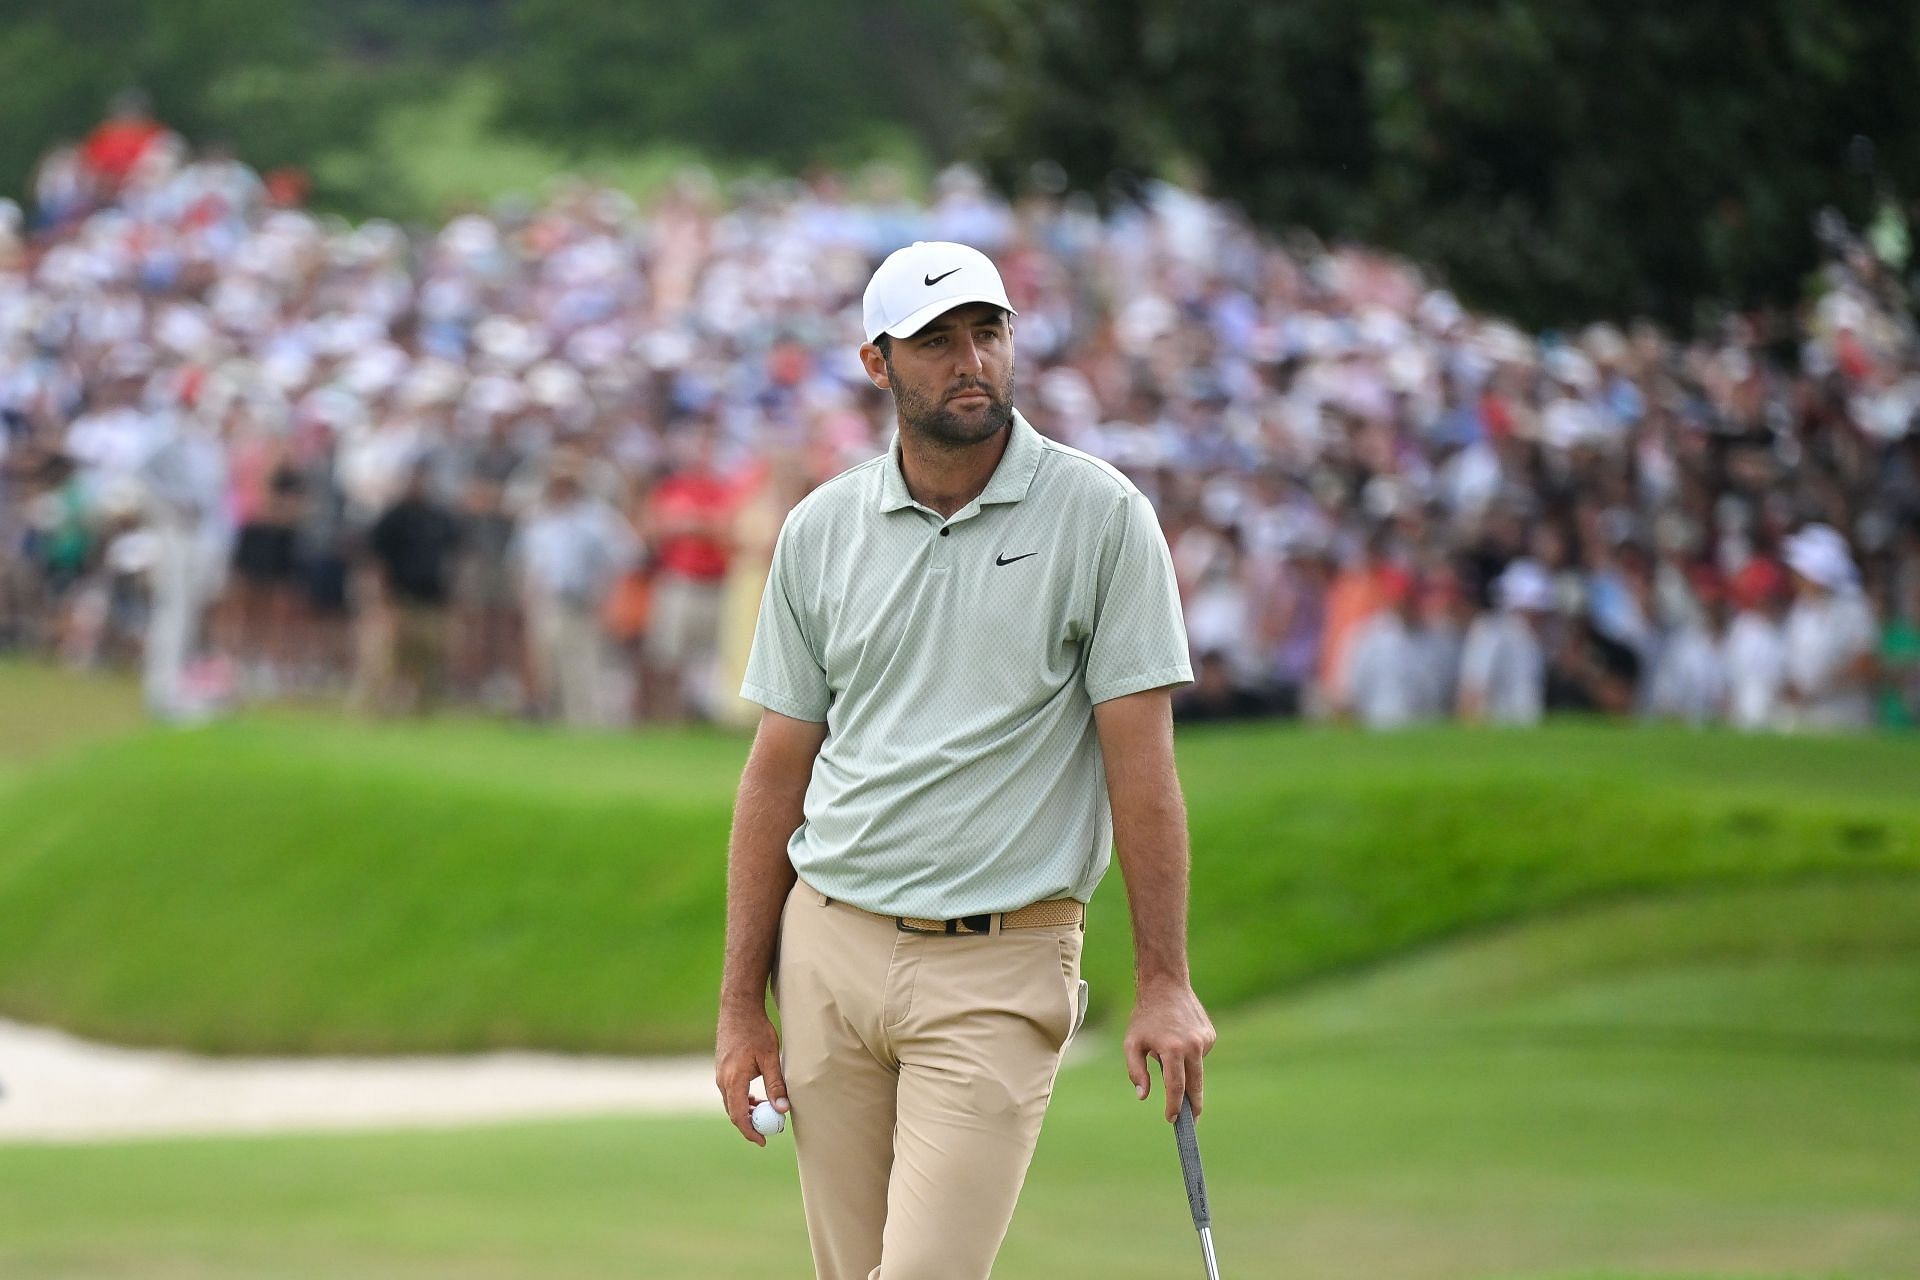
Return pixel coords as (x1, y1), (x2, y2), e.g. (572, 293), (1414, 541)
(0, 0), (970, 217)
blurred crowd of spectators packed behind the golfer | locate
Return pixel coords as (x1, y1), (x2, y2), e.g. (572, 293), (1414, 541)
(0, 102), (1920, 729)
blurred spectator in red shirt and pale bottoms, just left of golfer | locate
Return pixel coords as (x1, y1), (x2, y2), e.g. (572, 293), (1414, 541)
(641, 424), (737, 720)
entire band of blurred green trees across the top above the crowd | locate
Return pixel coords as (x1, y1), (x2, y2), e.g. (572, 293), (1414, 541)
(0, 0), (1920, 324)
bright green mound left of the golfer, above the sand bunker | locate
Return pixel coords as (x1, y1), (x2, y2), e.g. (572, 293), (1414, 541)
(0, 718), (739, 1052)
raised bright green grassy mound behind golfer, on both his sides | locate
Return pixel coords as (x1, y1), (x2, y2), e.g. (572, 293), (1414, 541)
(0, 690), (1920, 1052)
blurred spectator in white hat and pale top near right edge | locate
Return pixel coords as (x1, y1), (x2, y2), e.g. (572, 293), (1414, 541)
(1786, 524), (1880, 731)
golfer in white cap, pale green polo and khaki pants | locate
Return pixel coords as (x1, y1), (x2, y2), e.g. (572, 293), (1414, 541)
(716, 244), (1213, 1280)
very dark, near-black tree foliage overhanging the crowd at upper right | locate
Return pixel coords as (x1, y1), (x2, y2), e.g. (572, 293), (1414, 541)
(972, 0), (1920, 324)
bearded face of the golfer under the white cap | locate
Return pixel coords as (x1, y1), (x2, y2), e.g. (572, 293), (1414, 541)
(860, 303), (1014, 449)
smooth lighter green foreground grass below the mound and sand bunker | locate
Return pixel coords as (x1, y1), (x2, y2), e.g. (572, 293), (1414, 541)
(0, 877), (1920, 1280)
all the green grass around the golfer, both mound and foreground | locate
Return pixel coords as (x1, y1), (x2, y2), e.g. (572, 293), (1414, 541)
(0, 668), (1920, 1280)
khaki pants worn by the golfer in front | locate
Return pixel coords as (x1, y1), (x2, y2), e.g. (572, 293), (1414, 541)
(774, 881), (1085, 1280)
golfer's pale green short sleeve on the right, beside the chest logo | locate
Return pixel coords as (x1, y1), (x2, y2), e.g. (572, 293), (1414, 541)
(1087, 489), (1194, 702)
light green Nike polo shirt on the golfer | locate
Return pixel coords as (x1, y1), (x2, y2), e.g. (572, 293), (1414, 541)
(741, 413), (1192, 917)
